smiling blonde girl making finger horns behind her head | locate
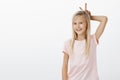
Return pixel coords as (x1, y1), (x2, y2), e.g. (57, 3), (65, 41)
(62, 4), (107, 80)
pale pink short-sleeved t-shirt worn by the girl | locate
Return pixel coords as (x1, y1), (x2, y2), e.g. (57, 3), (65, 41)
(63, 34), (99, 80)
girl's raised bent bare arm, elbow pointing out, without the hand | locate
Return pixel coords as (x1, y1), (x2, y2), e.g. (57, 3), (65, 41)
(91, 16), (108, 41)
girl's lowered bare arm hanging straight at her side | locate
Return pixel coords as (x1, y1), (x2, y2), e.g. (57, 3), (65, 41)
(62, 52), (69, 80)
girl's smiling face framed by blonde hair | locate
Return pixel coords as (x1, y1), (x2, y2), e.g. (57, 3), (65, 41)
(73, 15), (87, 35)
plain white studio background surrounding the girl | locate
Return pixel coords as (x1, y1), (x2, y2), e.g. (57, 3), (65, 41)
(0, 0), (120, 80)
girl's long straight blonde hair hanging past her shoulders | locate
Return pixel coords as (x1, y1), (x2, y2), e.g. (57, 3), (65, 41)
(71, 11), (90, 57)
